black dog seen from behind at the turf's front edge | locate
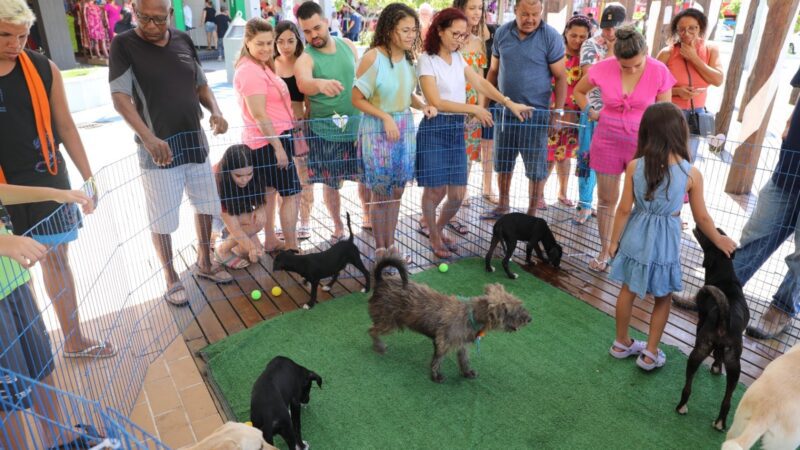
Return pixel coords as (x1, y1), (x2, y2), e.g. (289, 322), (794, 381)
(250, 356), (322, 450)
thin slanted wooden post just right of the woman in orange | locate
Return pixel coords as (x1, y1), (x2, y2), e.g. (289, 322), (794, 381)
(716, 0), (761, 136)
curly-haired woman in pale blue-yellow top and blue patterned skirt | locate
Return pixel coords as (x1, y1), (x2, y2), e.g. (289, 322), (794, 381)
(353, 3), (436, 259)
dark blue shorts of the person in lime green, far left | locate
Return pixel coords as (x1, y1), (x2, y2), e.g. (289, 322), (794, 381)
(0, 283), (54, 412)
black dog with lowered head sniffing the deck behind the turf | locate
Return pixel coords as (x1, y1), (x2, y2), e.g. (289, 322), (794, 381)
(486, 213), (564, 279)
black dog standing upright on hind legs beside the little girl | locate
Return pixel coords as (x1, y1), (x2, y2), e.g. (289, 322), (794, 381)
(675, 228), (750, 431)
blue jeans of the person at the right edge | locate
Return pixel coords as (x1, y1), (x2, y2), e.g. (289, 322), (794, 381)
(733, 180), (800, 317)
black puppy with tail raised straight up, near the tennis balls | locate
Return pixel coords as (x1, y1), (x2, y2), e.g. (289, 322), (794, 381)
(272, 213), (370, 309)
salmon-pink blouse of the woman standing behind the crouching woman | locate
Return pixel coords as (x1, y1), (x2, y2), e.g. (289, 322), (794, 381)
(233, 58), (293, 150)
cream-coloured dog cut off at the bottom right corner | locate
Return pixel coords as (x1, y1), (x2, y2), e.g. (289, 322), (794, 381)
(722, 345), (800, 450)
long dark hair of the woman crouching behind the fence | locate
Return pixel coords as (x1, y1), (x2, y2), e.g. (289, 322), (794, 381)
(216, 144), (266, 216)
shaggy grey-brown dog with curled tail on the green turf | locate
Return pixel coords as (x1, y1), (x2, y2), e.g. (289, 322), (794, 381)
(369, 257), (531, 383)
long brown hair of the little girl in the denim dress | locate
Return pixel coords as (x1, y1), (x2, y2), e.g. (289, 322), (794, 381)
(635, 102), (690, 201)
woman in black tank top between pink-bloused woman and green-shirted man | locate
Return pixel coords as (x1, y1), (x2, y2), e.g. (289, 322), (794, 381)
(274, 20), (314, 243)
